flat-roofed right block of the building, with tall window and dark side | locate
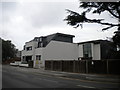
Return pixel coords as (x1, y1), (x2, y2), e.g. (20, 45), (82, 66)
(78, 40), (117, 60)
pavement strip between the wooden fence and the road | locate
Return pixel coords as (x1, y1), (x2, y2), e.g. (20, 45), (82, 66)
(12, 66), (120, 83)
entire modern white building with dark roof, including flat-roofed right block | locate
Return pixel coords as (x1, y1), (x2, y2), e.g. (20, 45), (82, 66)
(21, 33), (114, 69)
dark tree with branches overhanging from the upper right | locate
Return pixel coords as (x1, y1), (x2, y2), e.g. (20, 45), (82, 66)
(64, 1), (120, 47)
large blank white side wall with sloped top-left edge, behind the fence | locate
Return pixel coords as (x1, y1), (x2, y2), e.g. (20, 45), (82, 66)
(44, 41), (78, 60)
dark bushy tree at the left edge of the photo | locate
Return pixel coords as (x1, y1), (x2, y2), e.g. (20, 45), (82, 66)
(2, 39), (16, 62)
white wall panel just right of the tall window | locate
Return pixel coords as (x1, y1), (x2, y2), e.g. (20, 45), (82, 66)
(93, 44), (101, 60)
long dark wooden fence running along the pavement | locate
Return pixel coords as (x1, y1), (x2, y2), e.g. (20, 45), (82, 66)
(45, 60), (120, 74)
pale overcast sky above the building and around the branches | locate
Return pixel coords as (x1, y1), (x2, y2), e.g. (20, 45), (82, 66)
(0, 0), (117, 50)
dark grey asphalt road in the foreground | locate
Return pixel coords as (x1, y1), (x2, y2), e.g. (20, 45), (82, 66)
(2, 65), (120, 90)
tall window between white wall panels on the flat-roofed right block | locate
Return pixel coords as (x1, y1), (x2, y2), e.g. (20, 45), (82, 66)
(83, 43), (92, 58)
